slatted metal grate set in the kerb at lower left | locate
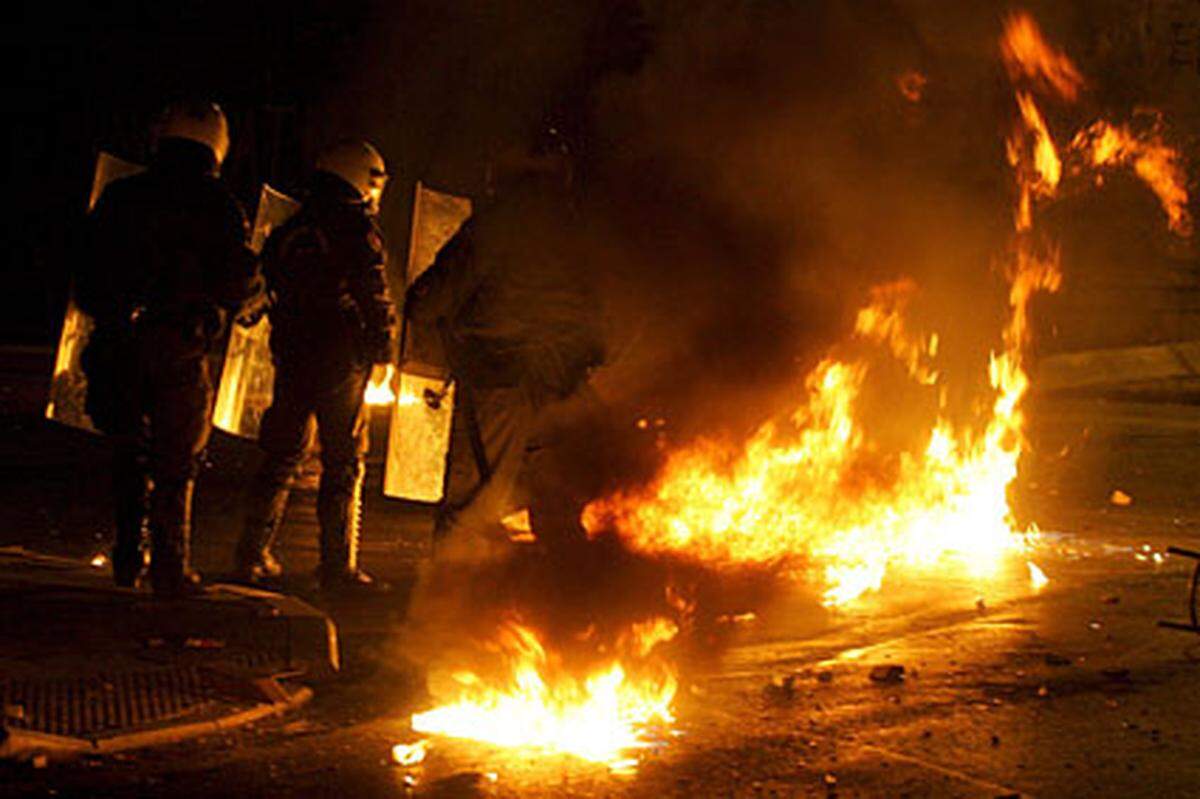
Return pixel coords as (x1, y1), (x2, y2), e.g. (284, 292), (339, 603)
(0, 666), (230, 738)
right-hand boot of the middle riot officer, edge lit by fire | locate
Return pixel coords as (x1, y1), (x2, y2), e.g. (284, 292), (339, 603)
(317, 464), (391, 594)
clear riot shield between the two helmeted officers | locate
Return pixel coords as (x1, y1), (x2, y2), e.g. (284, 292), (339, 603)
(212, 185), (300, 438)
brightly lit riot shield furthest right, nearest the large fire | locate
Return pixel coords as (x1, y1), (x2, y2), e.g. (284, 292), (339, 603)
(383, 182), (470, 503)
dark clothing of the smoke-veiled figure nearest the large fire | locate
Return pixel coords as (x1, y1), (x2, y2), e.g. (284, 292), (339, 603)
(404, 175), (604, 551)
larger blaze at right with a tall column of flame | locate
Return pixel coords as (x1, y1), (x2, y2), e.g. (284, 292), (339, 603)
(583, 14), (1190, 605)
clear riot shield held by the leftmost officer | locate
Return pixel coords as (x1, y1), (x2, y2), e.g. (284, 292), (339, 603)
(46, 152), (144, 432)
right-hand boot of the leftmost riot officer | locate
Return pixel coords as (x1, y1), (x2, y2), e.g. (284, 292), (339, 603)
(150, 480), (204, 597)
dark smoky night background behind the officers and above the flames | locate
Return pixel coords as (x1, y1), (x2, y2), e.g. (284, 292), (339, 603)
(0, 0), (1200, 441)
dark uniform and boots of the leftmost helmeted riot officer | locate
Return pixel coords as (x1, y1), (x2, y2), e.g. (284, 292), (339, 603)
(77, 138), (262, 594)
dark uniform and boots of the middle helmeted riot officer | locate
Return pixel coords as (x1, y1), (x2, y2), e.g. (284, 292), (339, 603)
(236, 172), (396, 582)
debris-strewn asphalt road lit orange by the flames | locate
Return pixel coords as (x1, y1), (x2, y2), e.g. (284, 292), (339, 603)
(0, 350), (1200, 798)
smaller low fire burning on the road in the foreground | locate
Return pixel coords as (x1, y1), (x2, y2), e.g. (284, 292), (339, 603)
(412, 619), (677, 764)
